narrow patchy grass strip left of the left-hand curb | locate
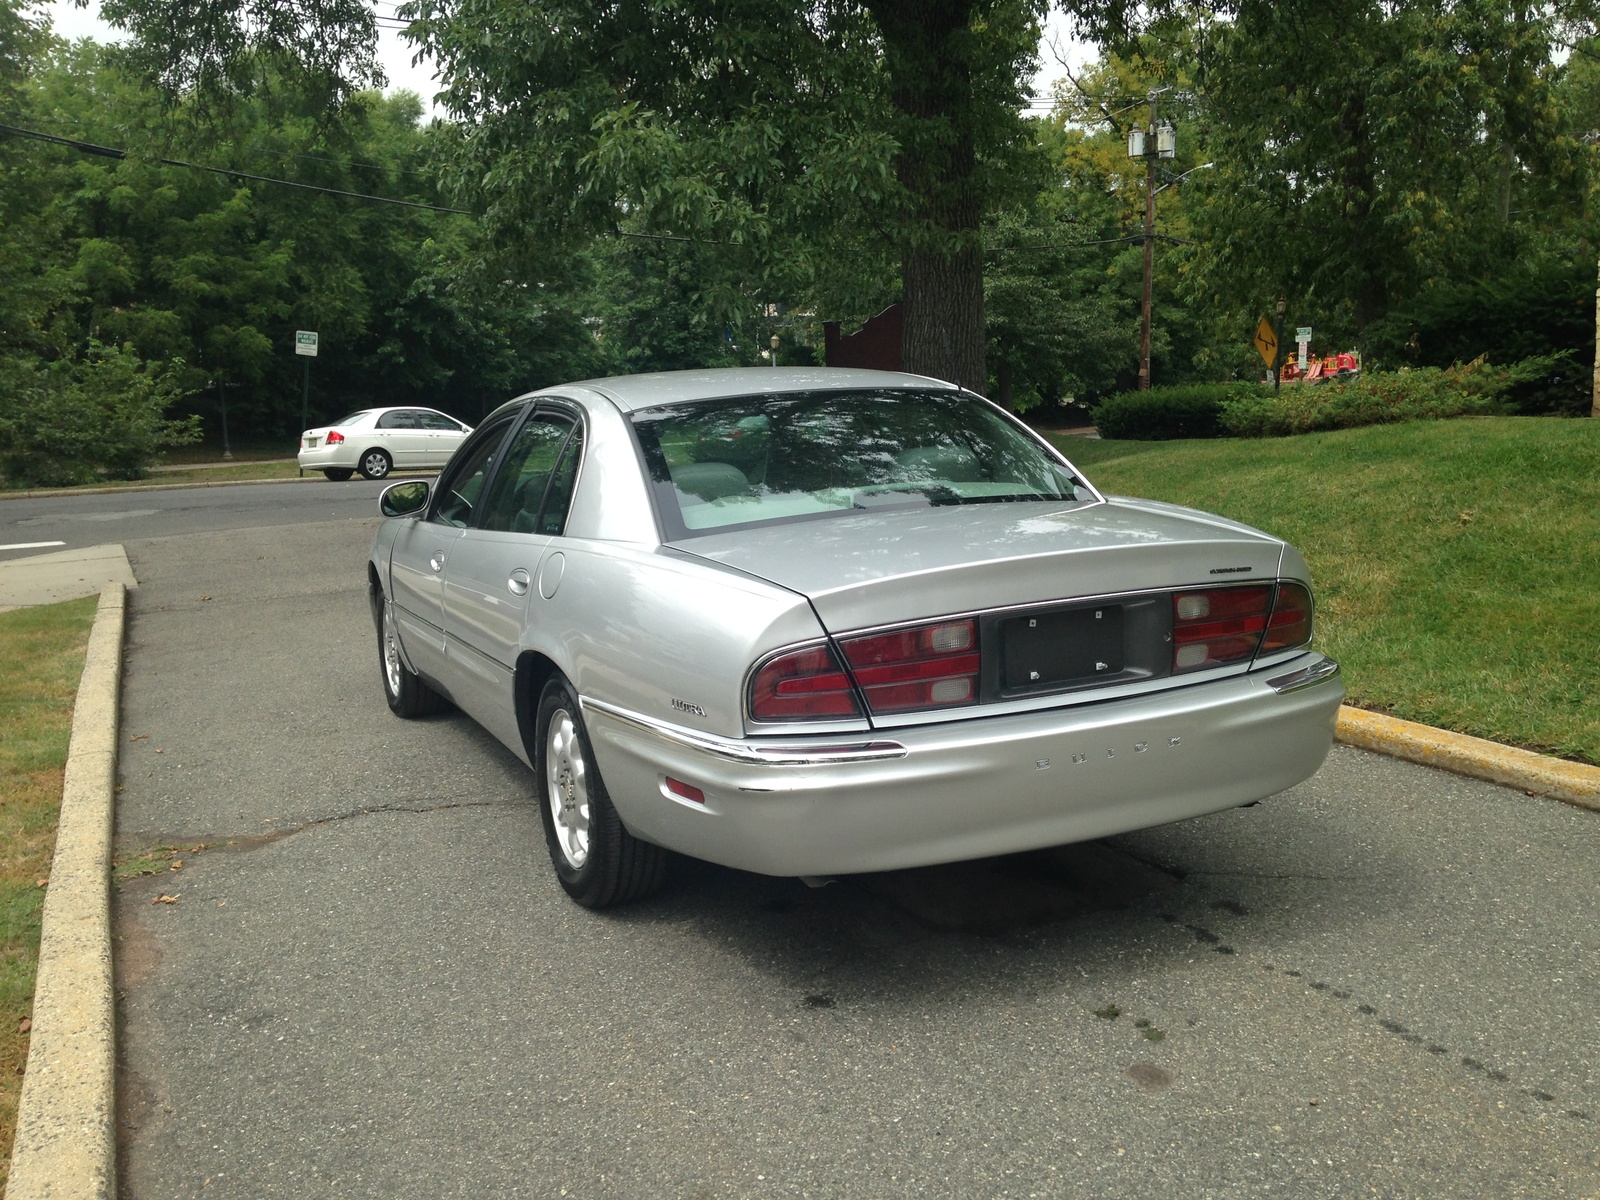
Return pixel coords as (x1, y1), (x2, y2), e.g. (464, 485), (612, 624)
(0, 597), (98, 1190)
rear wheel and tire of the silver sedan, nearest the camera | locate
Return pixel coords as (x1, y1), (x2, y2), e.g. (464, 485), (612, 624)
(533, 675), (669, 909)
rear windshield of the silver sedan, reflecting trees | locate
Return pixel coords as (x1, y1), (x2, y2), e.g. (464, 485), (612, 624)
(634, 390), (1094, 536)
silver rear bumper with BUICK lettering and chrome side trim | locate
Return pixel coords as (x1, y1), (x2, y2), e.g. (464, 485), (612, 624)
(584, 653), (1344, 875)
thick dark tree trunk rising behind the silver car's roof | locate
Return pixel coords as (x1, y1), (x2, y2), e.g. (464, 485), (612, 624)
(867, 0), (989, 392)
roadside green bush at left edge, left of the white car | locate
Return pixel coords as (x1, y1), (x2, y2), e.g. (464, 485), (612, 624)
(0, 344), (200, 486)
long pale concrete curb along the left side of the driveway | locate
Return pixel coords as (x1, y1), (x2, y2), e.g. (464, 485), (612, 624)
(5, 584), (128, 1200)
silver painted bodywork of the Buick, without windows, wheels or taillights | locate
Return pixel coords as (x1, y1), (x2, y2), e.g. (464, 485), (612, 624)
(373, 368), (1342, 875)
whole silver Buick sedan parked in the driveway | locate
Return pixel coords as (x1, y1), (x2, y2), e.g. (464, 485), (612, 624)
(368, 368), (1344, 907)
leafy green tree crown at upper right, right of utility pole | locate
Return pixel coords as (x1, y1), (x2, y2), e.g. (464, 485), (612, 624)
(1194, 0), (1578, 352)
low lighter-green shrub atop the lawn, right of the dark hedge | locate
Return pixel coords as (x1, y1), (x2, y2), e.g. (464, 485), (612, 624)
(1219, 355), (1562, 437)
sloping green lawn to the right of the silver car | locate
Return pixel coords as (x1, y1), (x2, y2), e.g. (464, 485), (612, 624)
(1058, 418), (1600, 763)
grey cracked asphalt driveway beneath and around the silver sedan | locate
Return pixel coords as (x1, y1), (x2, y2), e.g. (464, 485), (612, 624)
(78, 485), (1600, 1200)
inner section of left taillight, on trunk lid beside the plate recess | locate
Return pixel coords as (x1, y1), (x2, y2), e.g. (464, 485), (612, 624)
(840, 621), (979, 712)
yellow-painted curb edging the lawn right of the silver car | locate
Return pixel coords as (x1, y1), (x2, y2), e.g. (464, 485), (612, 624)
(1336, 704), (1600, 811)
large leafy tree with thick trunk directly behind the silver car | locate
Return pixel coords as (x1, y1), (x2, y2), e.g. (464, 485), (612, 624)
(87, 0), (1045, 387)
